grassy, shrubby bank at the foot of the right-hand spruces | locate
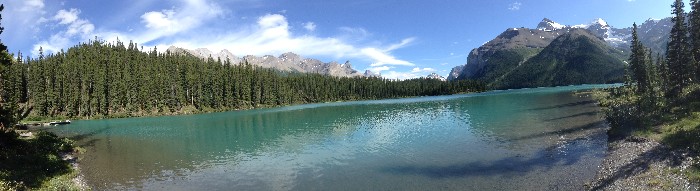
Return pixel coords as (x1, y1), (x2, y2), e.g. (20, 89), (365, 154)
(593, 86), (700, 183)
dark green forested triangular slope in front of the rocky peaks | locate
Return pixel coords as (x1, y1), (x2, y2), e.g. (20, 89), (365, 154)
(490, 29), (625, 89)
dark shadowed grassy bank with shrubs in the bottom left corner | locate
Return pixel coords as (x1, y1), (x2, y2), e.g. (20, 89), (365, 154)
(0, 131), (82, 191)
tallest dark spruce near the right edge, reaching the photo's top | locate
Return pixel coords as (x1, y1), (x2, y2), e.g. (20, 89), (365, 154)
(666, 0), (695, 98)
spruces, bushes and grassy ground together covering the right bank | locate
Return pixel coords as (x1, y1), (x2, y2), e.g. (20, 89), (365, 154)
(595, 0), (700, 182)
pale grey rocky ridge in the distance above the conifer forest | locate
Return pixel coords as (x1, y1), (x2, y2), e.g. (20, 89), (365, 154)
(167, 46), (370, 77)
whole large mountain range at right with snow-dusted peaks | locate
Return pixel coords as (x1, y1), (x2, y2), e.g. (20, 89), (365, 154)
(447, 18), (672, 89)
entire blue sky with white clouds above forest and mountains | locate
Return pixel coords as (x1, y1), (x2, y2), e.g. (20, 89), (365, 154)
(0, 0), (689, 79)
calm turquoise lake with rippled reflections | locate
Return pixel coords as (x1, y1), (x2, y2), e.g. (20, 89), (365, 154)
(50, 85), (609, 190)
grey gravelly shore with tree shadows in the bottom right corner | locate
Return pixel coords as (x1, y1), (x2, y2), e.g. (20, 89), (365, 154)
(586, 137), (698, 190)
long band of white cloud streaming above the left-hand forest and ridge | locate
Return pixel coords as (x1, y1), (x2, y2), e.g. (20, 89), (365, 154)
(34, 0), (415, 71)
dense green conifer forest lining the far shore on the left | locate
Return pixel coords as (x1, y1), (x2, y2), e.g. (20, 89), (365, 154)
(3, 40), (484, 118)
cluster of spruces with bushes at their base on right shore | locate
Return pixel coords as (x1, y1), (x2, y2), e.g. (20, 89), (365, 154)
(601, 0), (700, 137)
